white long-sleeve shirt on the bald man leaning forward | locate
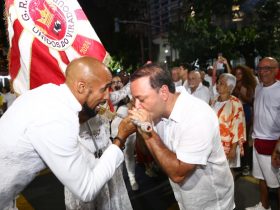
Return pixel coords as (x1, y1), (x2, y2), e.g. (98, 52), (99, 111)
(0, 84), (124, 209)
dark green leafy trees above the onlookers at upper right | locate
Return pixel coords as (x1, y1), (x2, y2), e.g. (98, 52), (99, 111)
(169, 0), (280, 67)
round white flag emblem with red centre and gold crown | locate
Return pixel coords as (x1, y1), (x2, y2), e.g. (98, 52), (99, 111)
(16, 0), (77, 50)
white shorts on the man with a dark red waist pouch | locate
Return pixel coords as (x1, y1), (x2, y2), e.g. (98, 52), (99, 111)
(252, 147), (280, 188)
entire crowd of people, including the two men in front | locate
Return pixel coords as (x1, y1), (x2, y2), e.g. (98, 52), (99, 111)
(0, 56), (280, 210)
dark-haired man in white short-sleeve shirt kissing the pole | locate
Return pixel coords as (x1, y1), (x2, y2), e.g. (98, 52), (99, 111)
(129, 64), (234, 210)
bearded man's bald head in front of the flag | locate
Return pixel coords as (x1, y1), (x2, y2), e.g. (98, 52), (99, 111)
(65, 57), (112, 109)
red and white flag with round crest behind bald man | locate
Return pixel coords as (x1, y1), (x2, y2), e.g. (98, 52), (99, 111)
(5, 0), (109, 94)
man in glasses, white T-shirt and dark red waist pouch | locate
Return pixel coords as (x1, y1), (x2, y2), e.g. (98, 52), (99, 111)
(246, 57), (280, 210)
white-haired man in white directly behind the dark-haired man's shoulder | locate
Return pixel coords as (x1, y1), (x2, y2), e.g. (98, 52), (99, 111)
(186, 71), (210, 104)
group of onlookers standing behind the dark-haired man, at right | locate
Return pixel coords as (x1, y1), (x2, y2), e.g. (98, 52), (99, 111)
(167, 57), (280, 210)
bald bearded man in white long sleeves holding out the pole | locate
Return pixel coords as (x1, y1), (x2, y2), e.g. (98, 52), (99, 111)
(0, 57), (135, 210)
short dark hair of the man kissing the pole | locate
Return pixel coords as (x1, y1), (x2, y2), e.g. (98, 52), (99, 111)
(130, 63), (175, 93)
